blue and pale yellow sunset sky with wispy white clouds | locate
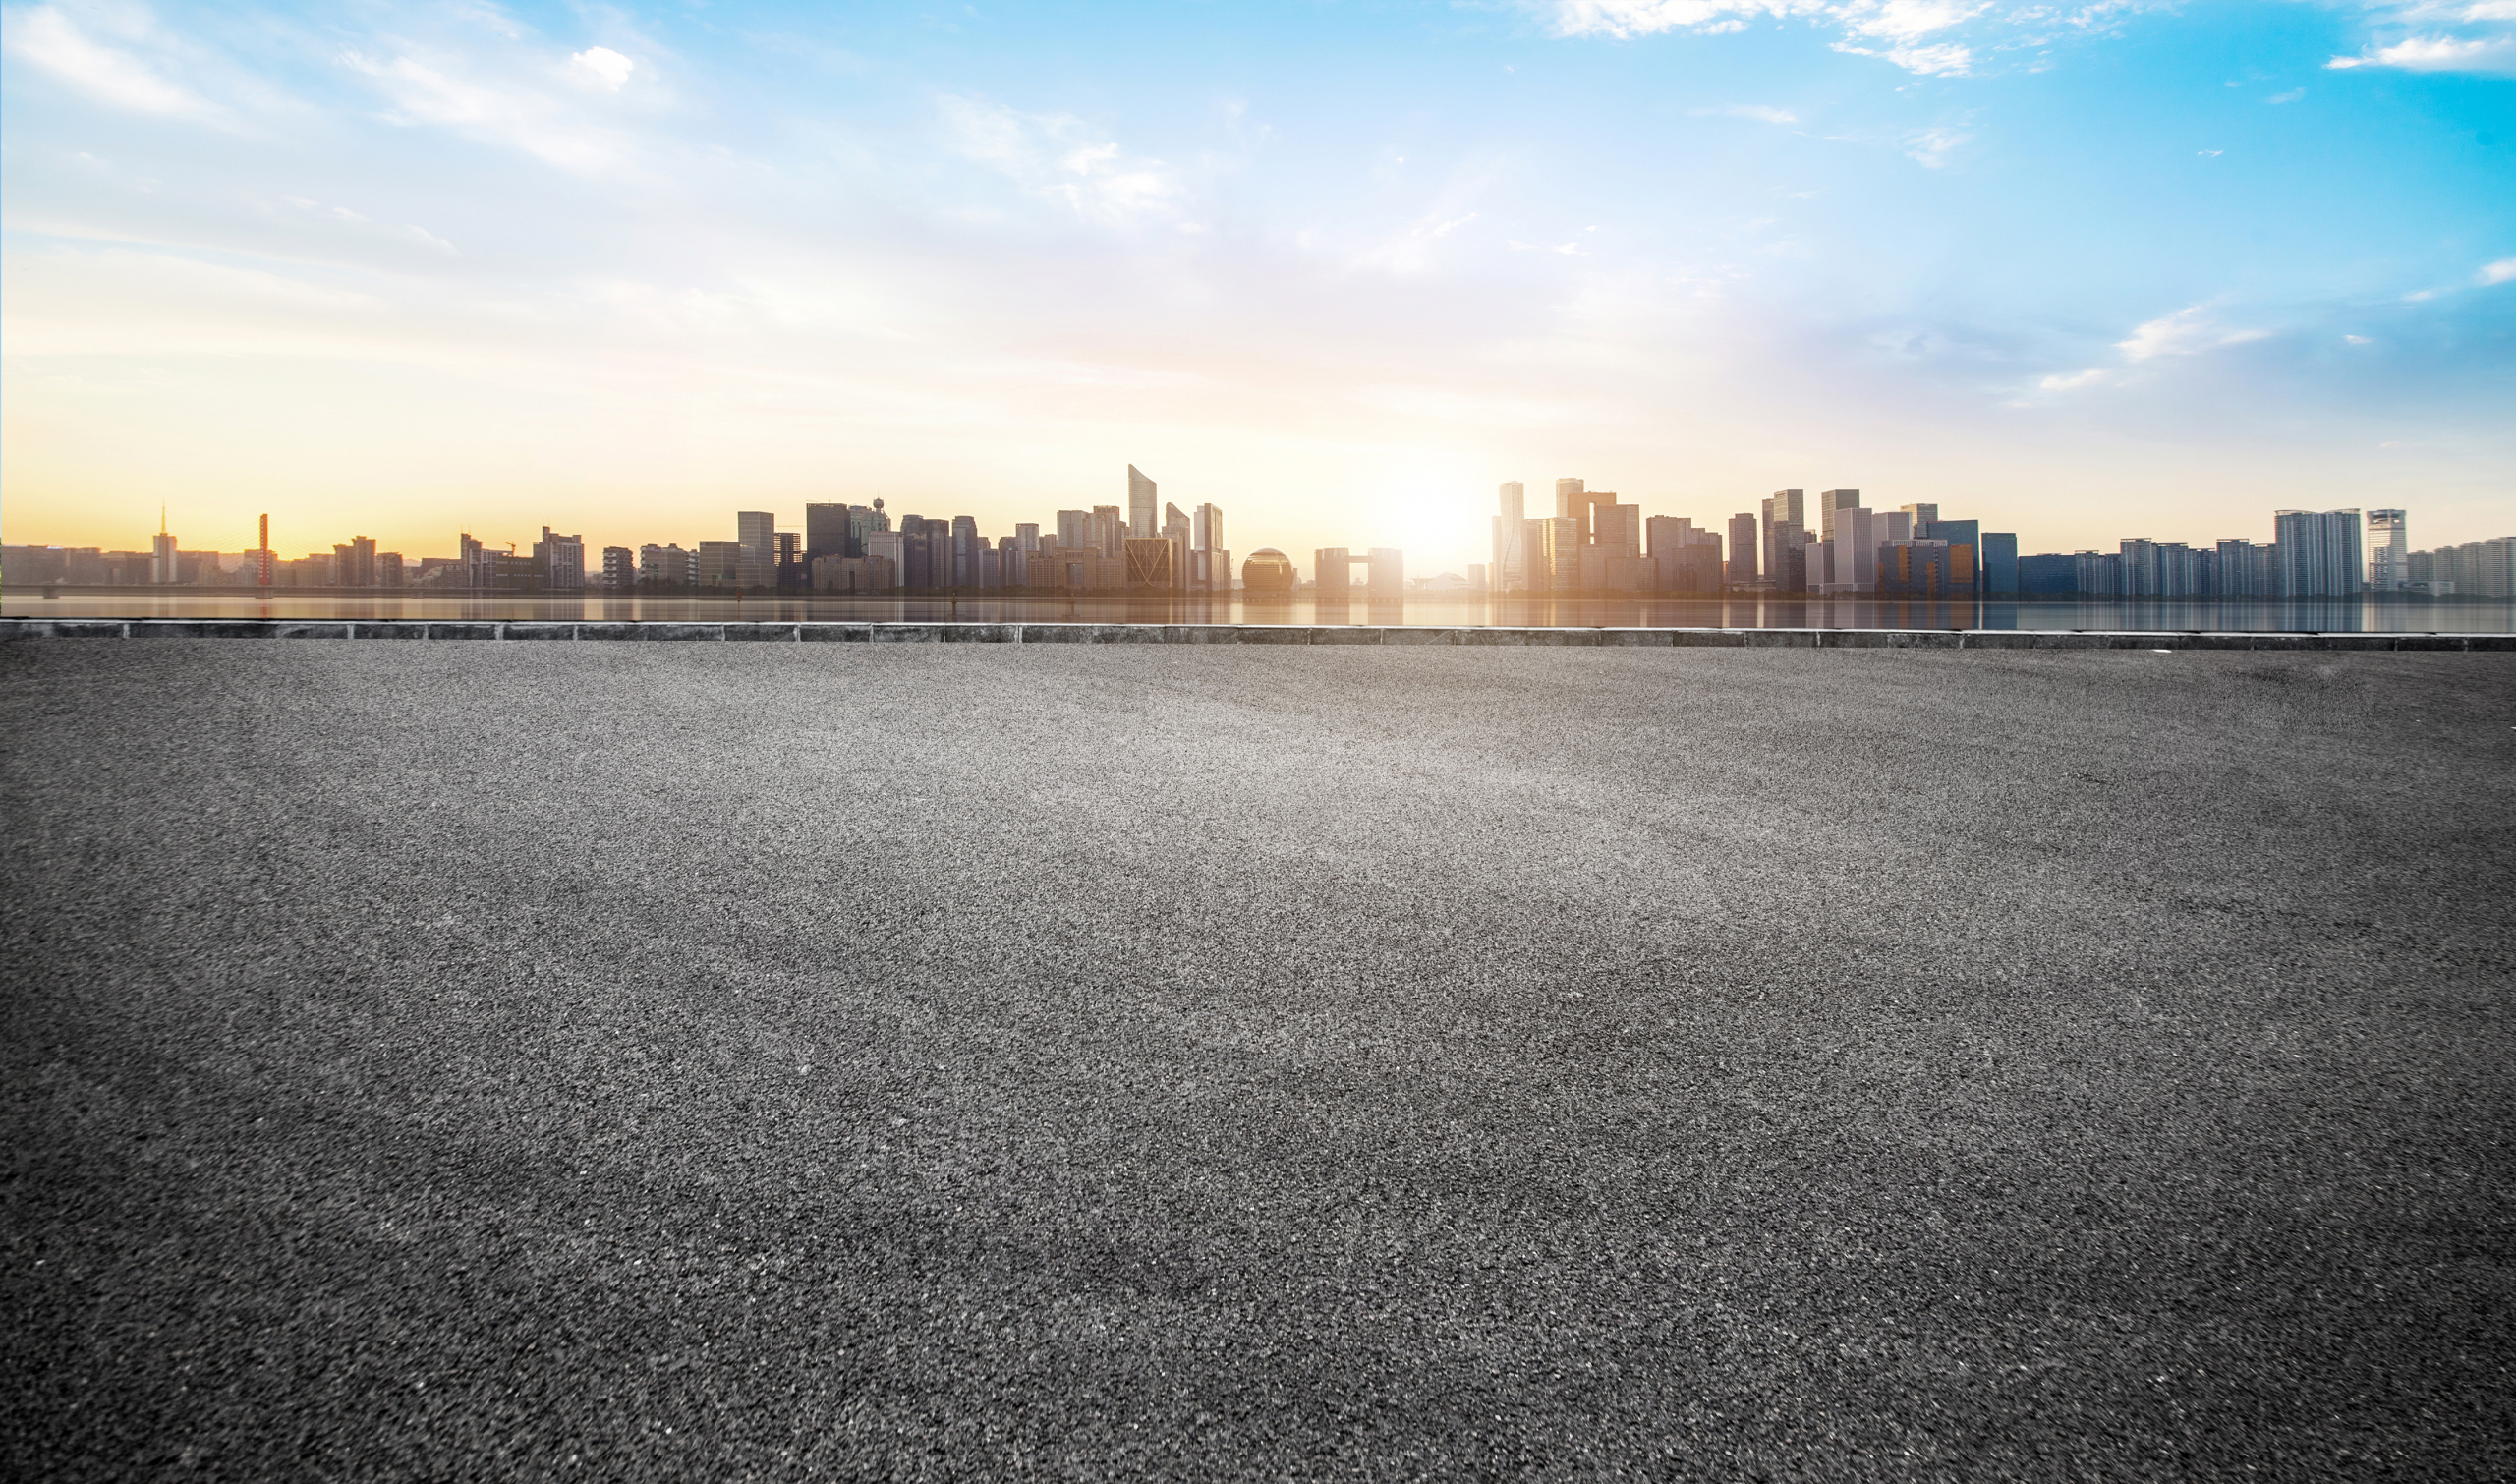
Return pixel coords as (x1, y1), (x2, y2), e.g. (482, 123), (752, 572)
(0, 0), (2516, 571)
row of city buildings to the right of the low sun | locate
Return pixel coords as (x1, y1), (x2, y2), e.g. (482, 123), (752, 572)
(1477, 478), (2516, 599)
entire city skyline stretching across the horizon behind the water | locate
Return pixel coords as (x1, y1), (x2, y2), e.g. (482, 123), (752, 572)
(0, 480), (2516, 601)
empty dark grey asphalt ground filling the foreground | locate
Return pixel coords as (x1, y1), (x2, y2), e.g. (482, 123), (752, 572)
(0, 639), (2516, 1479)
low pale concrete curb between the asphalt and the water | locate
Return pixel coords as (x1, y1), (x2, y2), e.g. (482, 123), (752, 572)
(0, 619), (2516, 652)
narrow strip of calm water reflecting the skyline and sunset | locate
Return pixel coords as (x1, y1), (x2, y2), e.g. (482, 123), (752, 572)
(0, 589), (2516, 634)
